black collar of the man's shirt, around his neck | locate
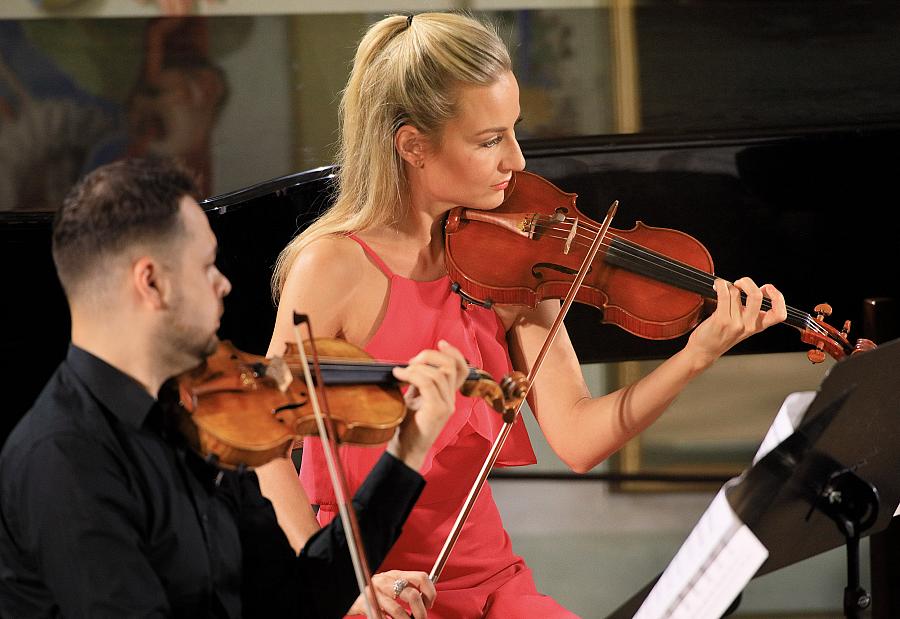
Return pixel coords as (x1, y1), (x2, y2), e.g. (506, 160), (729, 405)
(66, 344), (156, 428)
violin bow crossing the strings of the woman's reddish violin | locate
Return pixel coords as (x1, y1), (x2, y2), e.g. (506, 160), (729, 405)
(428, 200), (619, 583)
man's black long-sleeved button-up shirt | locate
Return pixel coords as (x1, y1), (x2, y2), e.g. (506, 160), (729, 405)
(0, 346), (424, 617)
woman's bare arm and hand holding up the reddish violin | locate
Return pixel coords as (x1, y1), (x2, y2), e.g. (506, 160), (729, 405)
(509, 278), (787, 472)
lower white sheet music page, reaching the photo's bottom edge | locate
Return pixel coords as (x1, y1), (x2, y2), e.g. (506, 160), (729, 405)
(635, 487), (769, 619)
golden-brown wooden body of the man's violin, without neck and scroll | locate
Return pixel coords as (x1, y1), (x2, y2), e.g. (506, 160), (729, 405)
(171, 340), (406, 468)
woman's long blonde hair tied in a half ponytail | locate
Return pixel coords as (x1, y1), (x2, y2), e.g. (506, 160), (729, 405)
(272, 13), (512, 302)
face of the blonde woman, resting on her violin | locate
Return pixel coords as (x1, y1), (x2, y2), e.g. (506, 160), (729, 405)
(415, 72), (525, 211)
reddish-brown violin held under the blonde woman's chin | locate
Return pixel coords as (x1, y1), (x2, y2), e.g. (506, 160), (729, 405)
(444, 171), (875, 363)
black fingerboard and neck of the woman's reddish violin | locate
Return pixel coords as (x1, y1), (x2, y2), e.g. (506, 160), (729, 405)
(603, 238), (816, 331)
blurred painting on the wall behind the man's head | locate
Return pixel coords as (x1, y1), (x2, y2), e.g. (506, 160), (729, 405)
(0, 18), (228, 211)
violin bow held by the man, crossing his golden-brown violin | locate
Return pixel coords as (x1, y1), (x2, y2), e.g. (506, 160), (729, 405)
(294, 312), (383, 619)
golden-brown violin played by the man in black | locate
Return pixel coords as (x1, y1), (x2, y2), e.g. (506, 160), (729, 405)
(174, 339), (525, 469)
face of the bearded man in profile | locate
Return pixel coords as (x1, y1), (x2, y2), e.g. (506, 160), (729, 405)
(162, 196), (231, 369)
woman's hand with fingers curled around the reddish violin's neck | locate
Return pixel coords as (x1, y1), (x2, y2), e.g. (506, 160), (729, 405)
(686, 277), (787, 364)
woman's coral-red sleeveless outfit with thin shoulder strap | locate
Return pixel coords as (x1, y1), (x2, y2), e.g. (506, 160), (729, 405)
(300, 236), (576, 619)
